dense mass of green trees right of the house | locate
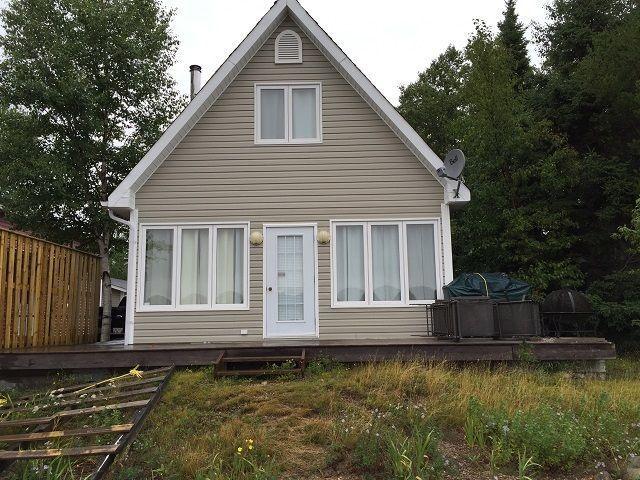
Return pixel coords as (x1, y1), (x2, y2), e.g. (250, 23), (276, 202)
(400, 0), (640, 334)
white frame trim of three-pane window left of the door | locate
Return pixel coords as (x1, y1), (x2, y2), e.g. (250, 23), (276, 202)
(136, 221), (251, 312)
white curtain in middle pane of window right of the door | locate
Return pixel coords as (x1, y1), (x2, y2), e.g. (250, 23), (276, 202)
(371, 225), (402, 301)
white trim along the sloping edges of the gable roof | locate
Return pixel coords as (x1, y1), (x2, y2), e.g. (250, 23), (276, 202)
(108, 0), (470, 209)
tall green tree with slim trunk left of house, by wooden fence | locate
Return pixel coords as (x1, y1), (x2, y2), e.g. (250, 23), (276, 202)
(0, 0), (184, 340)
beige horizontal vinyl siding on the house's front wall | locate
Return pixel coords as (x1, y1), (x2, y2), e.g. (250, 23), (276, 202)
(134, 19), (444, 343)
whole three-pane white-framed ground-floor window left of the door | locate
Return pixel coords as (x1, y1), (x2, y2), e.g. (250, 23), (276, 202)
(137, 223), (249, 311)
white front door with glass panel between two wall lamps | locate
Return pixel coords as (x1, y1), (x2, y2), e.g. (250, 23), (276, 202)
(264, 226), (316, 337)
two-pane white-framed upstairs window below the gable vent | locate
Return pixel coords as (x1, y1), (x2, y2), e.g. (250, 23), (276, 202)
(254, 82), (322, 144)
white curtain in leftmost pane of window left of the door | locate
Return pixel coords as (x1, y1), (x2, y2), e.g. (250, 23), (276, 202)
(144, 229), (173, 305)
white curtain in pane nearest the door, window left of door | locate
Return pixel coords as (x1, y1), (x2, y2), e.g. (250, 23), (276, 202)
(216, 228), (245, 305)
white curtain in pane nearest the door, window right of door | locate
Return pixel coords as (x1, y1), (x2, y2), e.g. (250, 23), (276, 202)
(335, 225), (364, 302)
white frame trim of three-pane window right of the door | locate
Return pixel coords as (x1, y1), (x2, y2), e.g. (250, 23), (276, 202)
(329, 218), (443, 308)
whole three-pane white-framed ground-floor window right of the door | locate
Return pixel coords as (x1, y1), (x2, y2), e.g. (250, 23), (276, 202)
(331, 219), (442, 307)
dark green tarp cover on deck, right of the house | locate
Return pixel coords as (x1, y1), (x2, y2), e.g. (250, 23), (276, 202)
(444, 273), (531, 302)
